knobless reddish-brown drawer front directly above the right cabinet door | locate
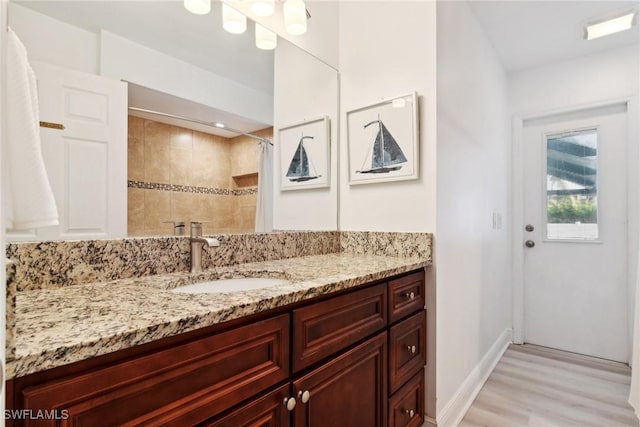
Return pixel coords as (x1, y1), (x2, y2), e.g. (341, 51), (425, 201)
(292, 283), (387, 372)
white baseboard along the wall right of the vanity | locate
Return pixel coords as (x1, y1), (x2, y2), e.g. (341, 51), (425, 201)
(438, 329), (511, 427)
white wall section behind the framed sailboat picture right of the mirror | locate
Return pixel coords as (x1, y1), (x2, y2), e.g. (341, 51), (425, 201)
(339, 1), (436, 232)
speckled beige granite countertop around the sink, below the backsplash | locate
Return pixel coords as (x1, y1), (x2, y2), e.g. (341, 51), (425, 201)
(7, 253), (430, 379)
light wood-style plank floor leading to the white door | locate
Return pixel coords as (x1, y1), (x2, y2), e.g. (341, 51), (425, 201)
(459, 344), (639, 427)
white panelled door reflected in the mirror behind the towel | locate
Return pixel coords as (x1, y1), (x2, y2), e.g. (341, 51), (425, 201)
(9, 63), (127, 240)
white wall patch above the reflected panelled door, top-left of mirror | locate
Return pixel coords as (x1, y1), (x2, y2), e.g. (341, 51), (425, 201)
(9, 2), (100, 74)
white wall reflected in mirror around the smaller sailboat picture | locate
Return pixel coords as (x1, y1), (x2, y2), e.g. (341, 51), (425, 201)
(273, 41), (339, 230)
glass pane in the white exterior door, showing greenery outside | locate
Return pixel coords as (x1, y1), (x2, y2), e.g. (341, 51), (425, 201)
(546, 129), (598, 240)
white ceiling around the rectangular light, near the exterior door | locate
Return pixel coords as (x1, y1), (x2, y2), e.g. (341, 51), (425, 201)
(468, 0), (640, 72)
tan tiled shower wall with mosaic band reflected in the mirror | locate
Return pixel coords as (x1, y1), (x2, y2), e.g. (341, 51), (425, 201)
(128, 116), (273, 236)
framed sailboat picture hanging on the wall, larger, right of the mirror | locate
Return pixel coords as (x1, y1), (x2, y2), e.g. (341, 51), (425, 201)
(347, 92), (419, 185)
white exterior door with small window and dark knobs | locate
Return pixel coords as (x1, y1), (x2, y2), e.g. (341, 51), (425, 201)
(522, 104), (628, 362)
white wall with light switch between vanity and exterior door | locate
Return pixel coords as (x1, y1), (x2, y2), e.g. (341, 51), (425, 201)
(435, 2), (512, 427)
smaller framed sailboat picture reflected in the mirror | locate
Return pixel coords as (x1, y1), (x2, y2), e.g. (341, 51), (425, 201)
(279, 117), (331, 191)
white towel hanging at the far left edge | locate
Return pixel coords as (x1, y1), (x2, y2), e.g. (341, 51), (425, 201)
(3, 29), (58, 230)
